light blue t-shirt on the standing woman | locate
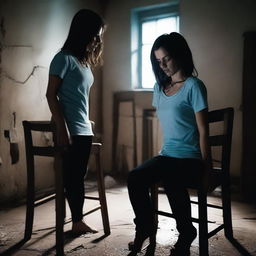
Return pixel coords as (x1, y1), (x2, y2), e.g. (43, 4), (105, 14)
(49, 51), (93, 136)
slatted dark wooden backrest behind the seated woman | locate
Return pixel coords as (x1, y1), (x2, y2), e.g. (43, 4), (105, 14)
(208, 108), (234, 178)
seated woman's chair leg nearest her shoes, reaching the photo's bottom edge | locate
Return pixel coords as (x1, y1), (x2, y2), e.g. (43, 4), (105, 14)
(198, 190), (209, 256)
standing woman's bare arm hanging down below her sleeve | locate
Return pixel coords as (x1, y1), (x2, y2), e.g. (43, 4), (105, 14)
(46, 75), (69, 146)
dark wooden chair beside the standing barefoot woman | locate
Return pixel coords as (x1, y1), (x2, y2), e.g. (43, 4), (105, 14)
(23, 121), (110, 255)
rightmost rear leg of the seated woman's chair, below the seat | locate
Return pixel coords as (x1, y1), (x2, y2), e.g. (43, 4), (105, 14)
(221, 185), (233, 239)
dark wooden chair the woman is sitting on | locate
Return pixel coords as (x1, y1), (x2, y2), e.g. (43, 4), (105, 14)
(151, 108), (234, 256)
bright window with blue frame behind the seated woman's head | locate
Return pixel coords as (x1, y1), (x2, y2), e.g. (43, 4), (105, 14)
(131, 4), (179, 89)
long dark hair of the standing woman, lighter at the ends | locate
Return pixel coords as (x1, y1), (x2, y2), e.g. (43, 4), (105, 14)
(61, 9), (105, 66)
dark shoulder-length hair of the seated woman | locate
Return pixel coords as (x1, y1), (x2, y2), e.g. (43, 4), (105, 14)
(150, 32), (198, 88)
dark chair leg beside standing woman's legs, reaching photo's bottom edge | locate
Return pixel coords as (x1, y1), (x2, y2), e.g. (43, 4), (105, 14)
(55, 153), (65, 256)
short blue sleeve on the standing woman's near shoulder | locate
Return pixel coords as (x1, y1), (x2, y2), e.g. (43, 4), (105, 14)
(49, 52), (69, 79)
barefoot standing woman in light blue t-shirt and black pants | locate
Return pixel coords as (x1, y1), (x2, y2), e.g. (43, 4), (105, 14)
(46, 9), (105, 235)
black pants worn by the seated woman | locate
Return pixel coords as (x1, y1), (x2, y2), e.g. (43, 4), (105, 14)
(128, 156), (203, 233)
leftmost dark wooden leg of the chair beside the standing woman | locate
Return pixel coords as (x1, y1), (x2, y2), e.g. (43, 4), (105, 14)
(24, 156), (35, 241)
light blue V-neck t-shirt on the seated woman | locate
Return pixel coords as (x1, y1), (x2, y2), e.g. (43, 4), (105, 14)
(152, 77), (208, 158)
